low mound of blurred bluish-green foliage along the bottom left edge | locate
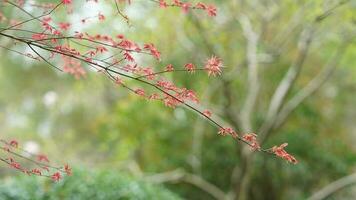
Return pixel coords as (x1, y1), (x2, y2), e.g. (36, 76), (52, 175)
(0, 170), (180, 200)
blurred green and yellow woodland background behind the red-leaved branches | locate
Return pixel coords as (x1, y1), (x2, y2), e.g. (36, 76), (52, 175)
(0, 0), (356, 200)
